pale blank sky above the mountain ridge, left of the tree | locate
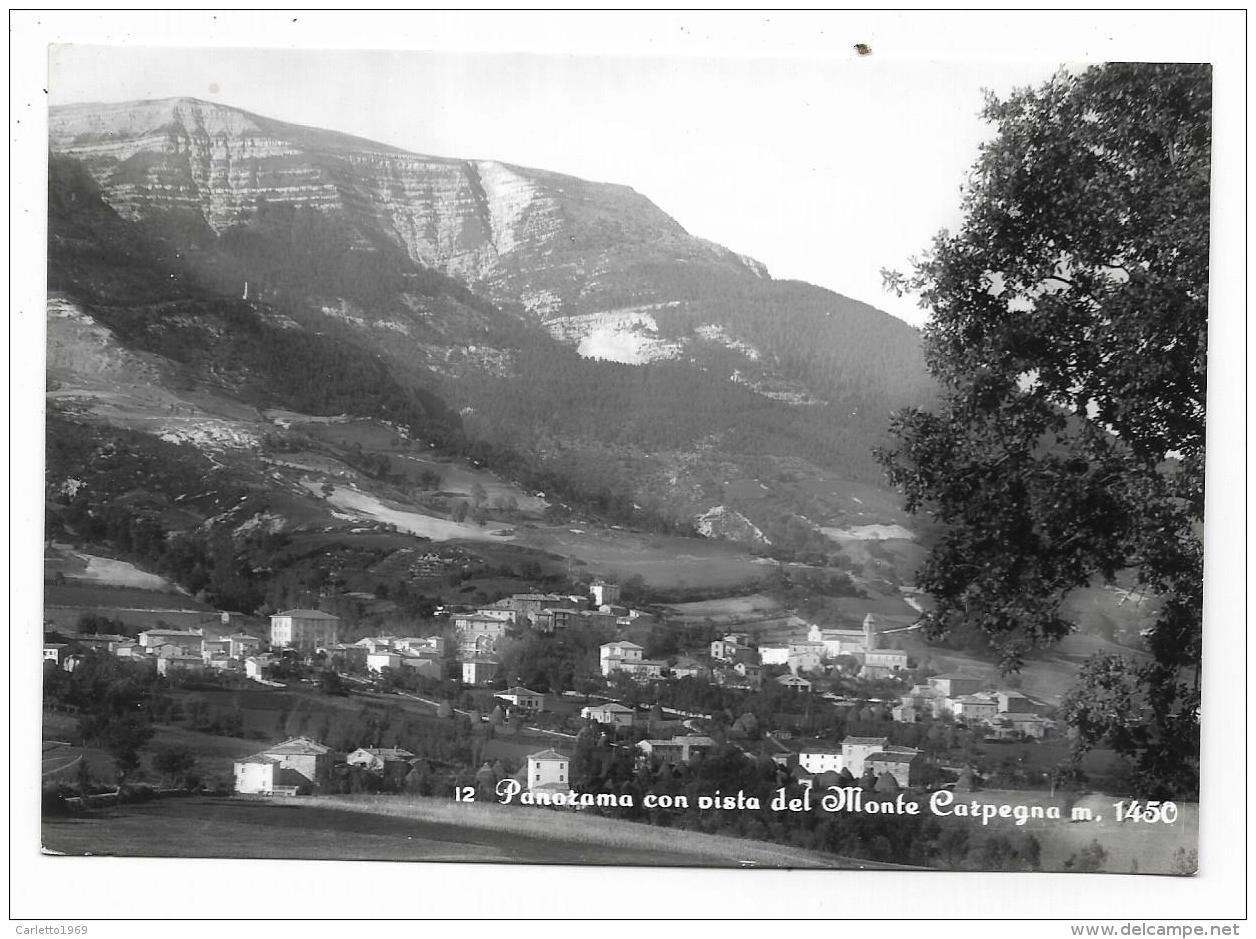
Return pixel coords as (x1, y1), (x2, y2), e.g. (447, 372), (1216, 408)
(49, 45), (1058, 324)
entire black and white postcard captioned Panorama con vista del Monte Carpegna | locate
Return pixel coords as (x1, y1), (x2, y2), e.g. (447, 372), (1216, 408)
(15, 10), (1241, 928)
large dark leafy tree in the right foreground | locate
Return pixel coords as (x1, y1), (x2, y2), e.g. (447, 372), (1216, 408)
(880, 64), (1211, 797)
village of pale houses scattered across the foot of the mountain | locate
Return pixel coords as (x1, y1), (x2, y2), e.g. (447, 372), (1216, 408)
(43, 579), (1058, 803)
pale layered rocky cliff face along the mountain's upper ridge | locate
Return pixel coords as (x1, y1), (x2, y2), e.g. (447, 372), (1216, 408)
(49, 98), (766, 316)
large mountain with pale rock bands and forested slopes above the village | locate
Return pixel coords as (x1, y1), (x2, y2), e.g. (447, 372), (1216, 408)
(49, 98), (931, 595)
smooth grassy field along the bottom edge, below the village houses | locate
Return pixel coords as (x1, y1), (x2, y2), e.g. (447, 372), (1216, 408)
(43, 796), (891, 869)
